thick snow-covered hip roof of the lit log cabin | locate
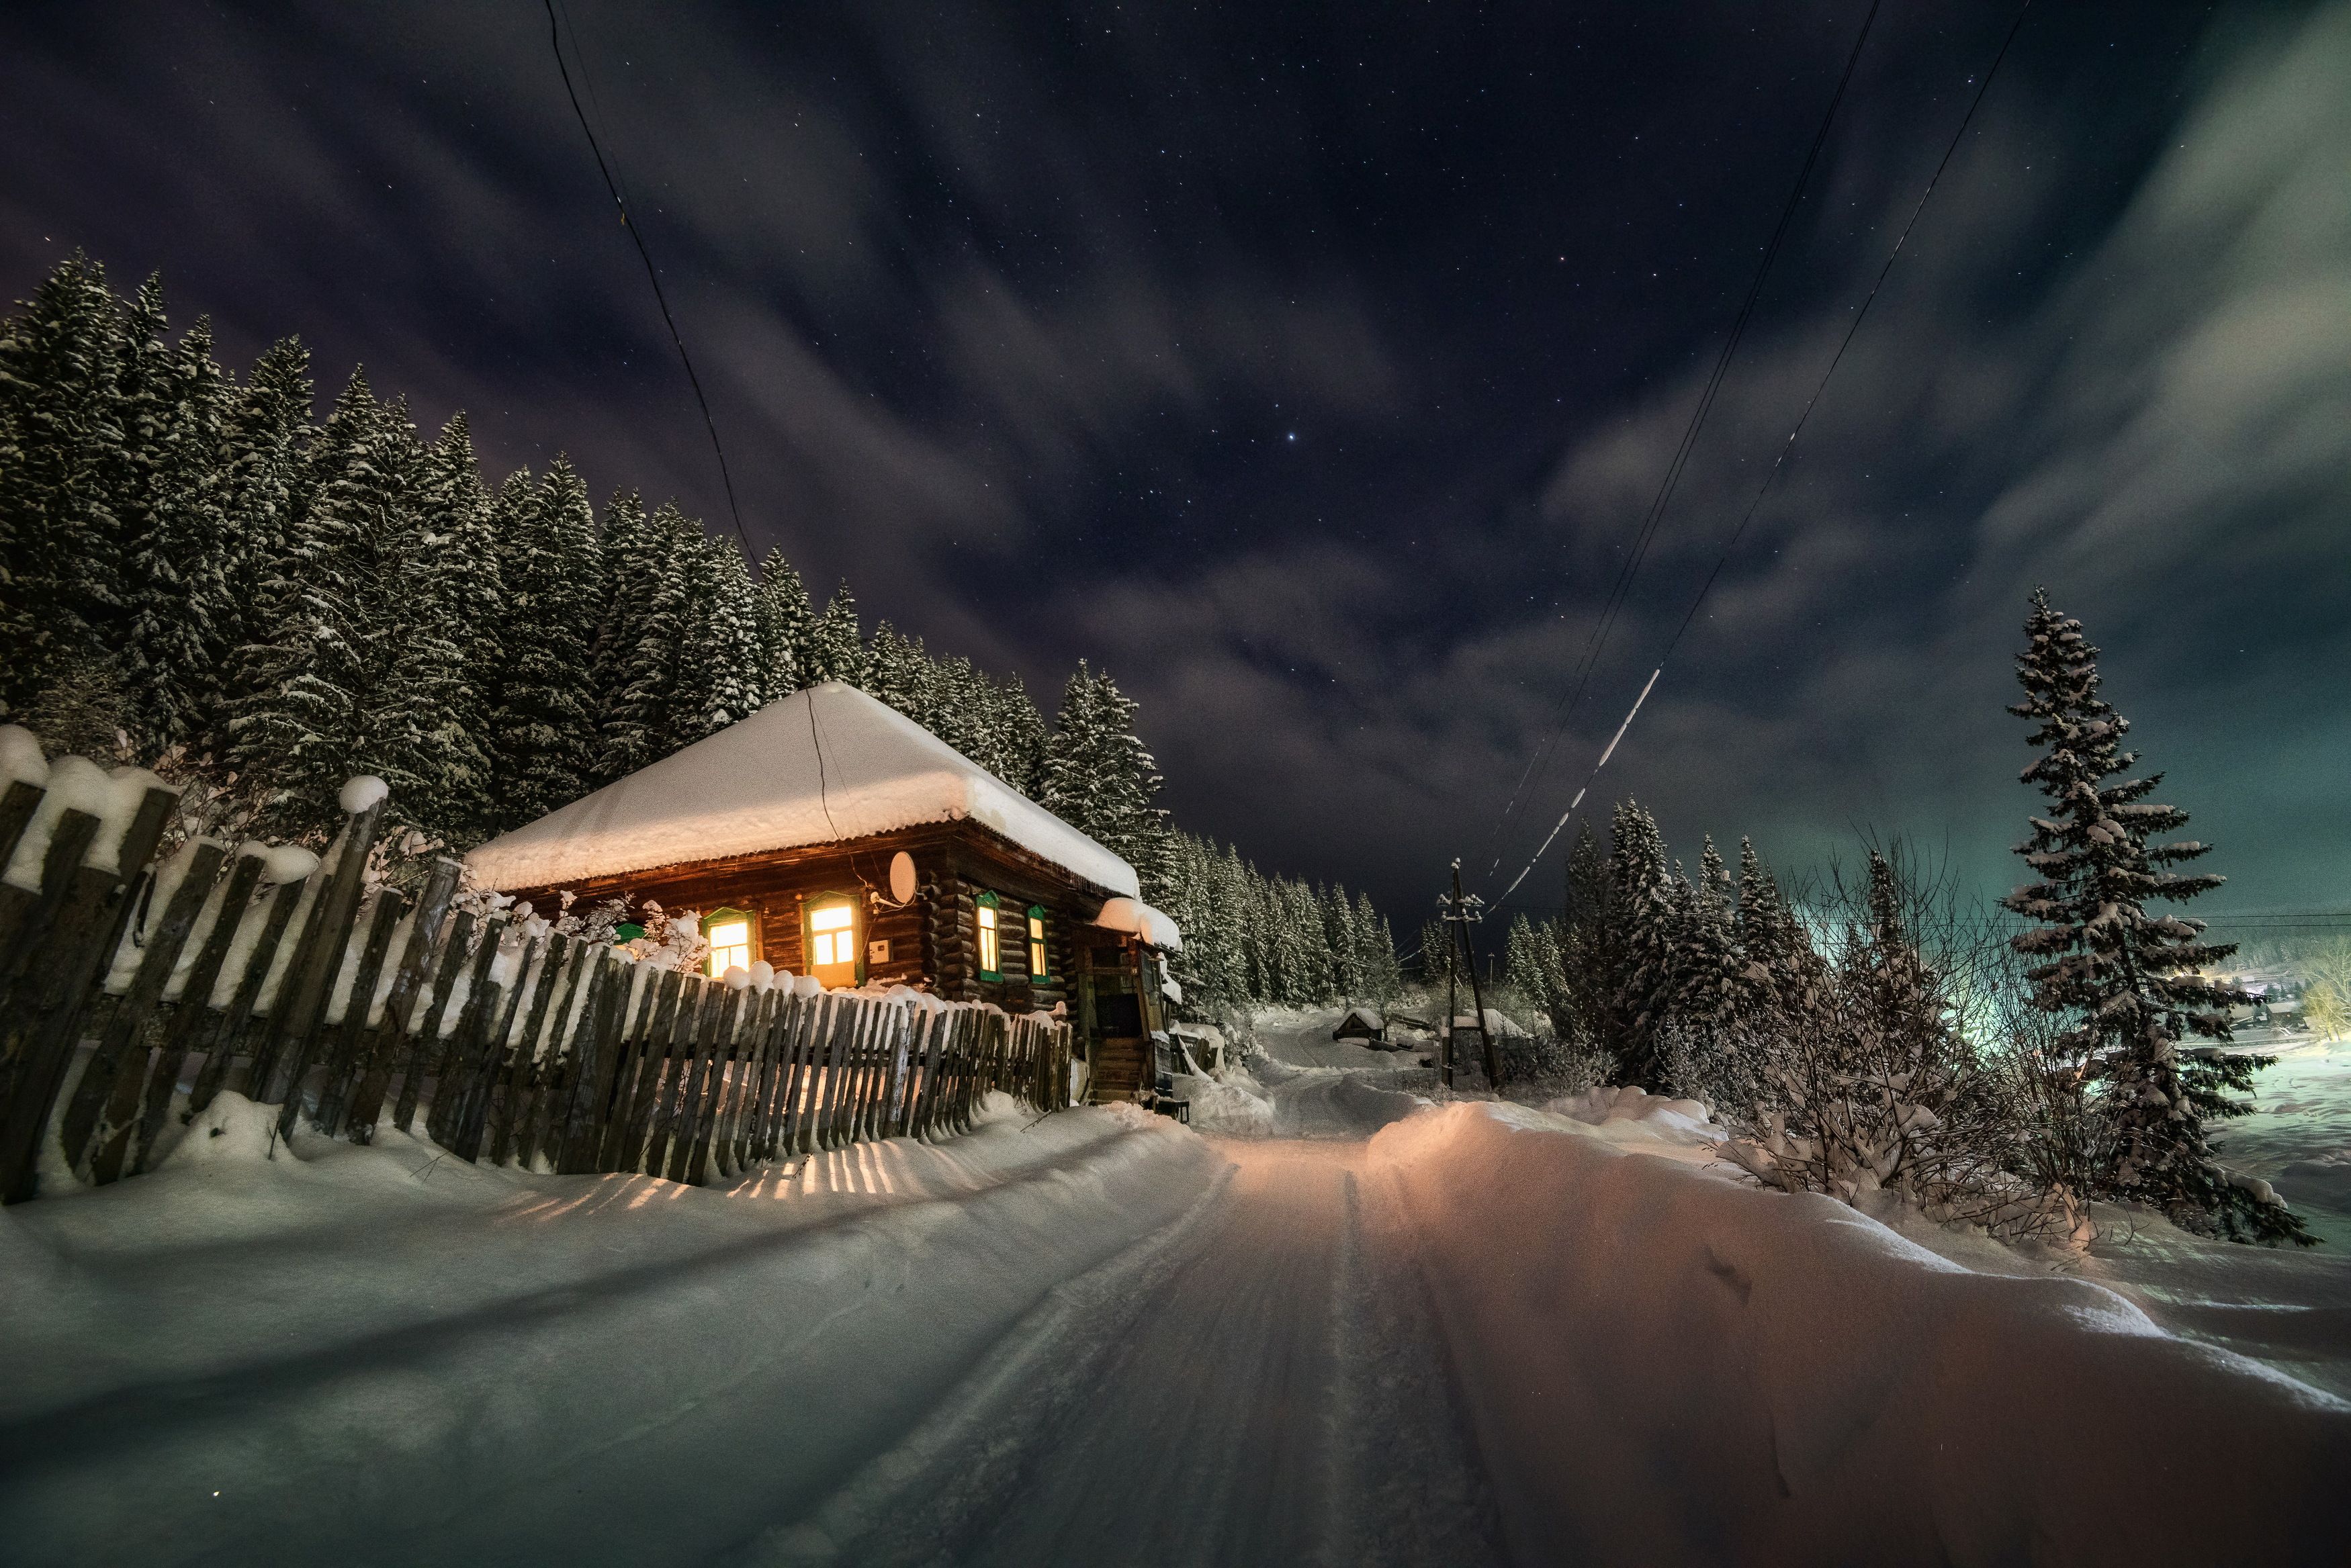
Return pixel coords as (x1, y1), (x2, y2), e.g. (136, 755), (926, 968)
(465, 682), (1136, 896)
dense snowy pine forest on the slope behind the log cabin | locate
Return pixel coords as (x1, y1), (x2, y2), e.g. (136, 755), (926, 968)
(0, 254), (1401, 1009)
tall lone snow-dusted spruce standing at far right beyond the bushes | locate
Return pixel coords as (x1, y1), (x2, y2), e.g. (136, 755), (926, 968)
(2003, 590), (2313, 1244)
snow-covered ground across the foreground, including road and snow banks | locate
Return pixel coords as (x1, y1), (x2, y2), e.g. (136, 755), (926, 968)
(0, 1015), (2351, 1563)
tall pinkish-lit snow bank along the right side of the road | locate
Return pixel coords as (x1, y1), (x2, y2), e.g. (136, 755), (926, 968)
(1371, 1105), (2351, 1563)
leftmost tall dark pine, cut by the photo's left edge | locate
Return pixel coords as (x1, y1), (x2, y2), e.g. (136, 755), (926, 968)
(0, 252), (125, 714)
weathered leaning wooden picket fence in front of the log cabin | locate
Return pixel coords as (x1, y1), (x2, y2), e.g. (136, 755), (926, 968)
(0, 762), (1070, 1203)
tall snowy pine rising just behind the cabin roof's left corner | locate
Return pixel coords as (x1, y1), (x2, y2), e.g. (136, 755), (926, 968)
(489, 456), (602, 827)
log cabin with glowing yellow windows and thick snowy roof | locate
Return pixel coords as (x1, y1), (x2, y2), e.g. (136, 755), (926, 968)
(465, 682), (1183, 1100)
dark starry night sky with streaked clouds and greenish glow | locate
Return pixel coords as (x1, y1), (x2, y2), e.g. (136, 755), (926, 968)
(0, 0), (2351, 921)
